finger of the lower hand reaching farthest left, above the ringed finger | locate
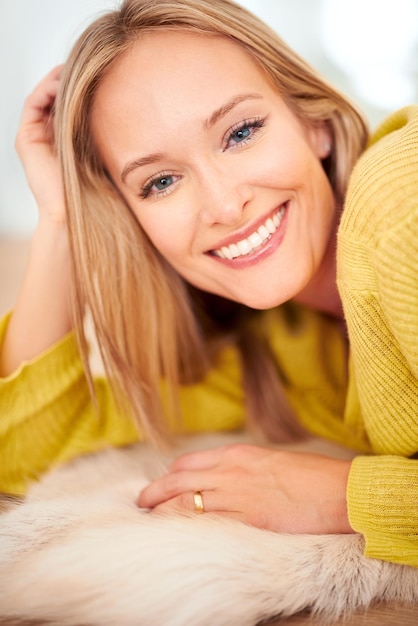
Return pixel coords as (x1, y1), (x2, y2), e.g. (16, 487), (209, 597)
(137, 471), (219, 509)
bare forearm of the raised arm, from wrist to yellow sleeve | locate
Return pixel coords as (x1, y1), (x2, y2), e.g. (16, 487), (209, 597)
(0, 220), (72, 377)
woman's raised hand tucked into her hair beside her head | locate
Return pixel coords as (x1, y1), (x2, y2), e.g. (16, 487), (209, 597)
(16, 65), (65, 224)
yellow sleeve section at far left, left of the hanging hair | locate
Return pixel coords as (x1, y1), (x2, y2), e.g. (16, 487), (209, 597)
(0, 316), (138, 493)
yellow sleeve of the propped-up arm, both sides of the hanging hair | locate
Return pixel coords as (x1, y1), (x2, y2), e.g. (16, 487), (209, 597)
(0, 316), (245, 493)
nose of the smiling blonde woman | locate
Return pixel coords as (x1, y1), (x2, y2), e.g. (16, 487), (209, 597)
(199, 165), (253, 226)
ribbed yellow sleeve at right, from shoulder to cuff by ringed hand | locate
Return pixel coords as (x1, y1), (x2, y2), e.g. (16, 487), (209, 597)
(338, 107), (418, 566)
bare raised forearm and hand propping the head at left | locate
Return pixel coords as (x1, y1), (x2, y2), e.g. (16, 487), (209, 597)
(0, 67), (72, 377)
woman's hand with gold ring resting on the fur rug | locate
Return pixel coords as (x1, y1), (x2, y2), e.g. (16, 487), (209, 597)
(137, 444), (353, 534)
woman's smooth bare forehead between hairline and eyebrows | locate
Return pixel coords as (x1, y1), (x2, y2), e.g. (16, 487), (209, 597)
(93, 31), (268, 127)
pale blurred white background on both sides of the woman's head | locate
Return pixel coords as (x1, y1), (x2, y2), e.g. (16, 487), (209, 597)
(0, 0), (418, 234)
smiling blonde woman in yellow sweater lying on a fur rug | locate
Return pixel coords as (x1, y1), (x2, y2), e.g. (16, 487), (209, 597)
(1, 0), (418, 565)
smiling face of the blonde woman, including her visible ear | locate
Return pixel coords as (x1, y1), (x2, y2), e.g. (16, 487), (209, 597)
(92, 32), (335, 309)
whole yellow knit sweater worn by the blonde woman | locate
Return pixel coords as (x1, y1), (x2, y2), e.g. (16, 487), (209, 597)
(0, 107), (418, 566)
